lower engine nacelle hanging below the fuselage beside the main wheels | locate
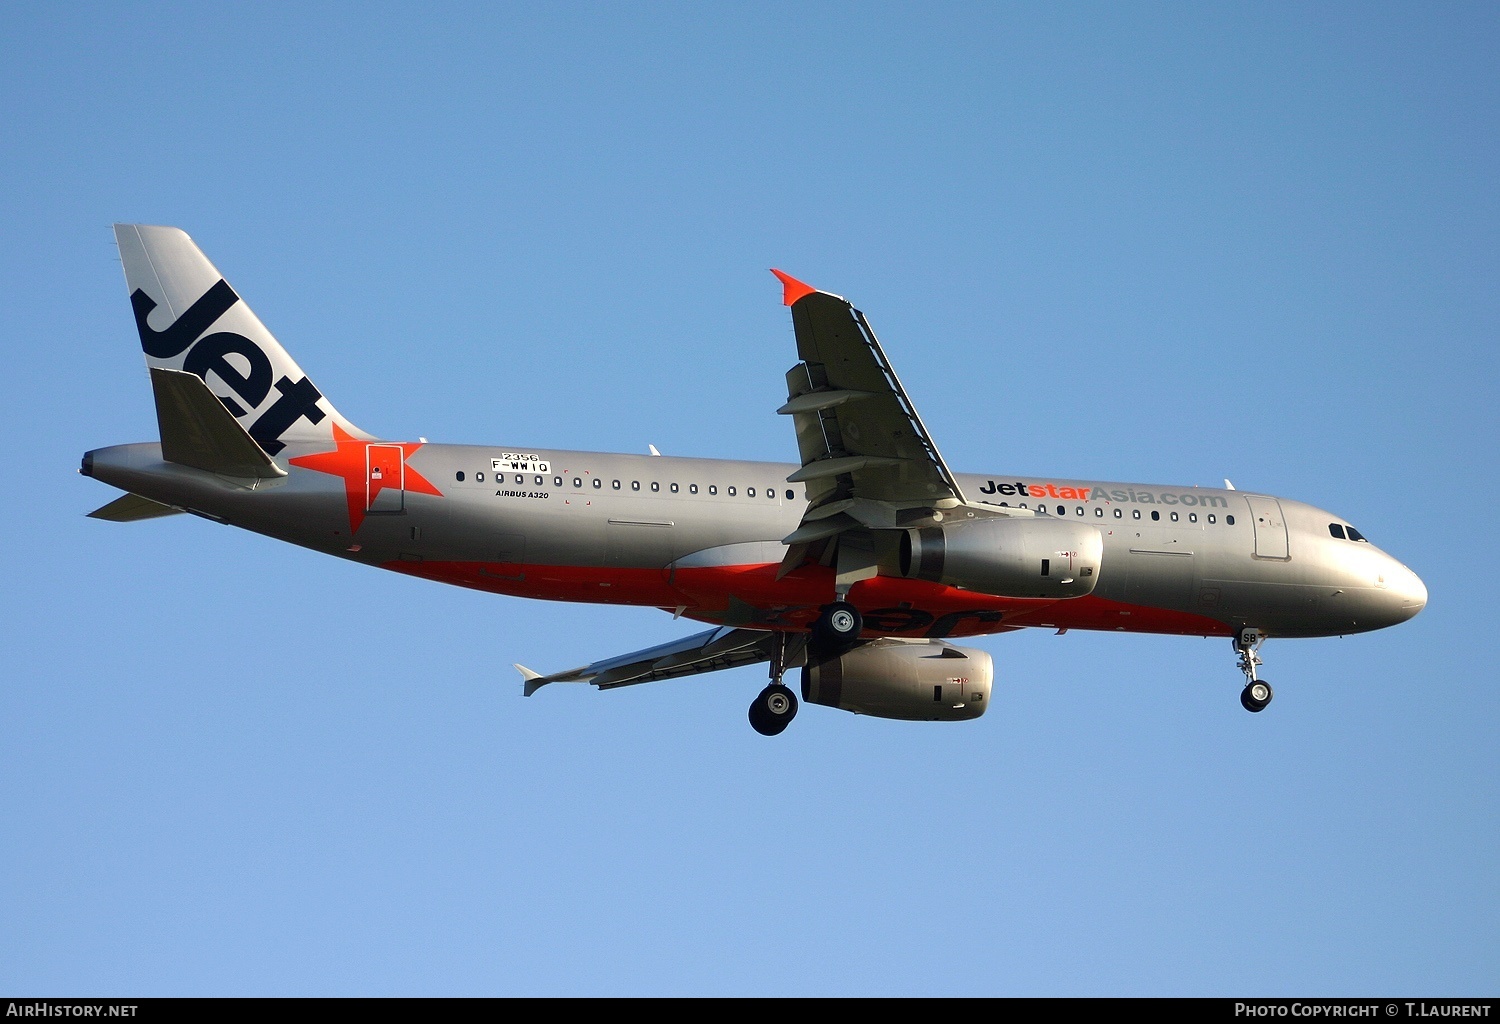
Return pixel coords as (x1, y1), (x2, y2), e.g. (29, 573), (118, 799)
(803, 639), (995, 721)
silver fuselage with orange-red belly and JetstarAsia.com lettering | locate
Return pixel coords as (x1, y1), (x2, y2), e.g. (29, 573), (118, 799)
(84, 441), (1427, 637)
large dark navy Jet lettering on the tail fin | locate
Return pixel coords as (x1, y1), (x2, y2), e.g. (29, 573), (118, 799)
(131, 277), (326, 456)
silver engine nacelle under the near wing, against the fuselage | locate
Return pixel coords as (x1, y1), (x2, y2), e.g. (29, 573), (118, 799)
(902, 516), (1104, 598)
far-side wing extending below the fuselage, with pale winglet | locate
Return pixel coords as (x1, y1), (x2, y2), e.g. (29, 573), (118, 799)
(516, 627), (806, 697)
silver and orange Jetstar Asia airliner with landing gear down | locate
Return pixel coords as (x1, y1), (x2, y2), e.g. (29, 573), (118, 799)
(80, 223), (1427, 736)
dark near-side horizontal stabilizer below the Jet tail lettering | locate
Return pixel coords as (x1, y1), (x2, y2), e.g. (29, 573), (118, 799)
(152, 366), (287, 480)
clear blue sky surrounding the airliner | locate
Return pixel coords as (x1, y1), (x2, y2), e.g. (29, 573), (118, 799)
(0, 3), (1500, 996)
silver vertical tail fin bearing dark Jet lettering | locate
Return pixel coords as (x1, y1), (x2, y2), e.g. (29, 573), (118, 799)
(114, 223), (371, 456)
